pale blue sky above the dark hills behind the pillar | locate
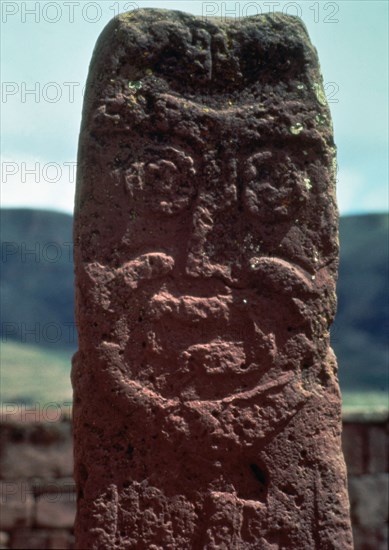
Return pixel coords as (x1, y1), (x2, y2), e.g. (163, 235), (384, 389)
(1, 0), (389, 214)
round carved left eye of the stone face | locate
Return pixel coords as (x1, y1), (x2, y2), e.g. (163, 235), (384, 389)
(126, 147), (196, 214)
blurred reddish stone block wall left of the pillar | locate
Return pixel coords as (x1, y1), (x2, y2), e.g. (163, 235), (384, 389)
(0, 415), (76, 549)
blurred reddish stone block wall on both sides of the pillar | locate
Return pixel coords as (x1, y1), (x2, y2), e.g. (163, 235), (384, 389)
(0, 411), (389, 550)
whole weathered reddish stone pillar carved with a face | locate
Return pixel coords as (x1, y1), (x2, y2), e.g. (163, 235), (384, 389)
(72, 10), (352, 550)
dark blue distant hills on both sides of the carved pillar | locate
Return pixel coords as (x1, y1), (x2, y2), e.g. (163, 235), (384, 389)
(1, 209), (389, 391)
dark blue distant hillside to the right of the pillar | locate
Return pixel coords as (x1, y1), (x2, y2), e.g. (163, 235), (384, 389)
(332, 214), (389, 391)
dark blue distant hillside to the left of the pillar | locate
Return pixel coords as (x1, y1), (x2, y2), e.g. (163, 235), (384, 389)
(0, 209), (76, 348)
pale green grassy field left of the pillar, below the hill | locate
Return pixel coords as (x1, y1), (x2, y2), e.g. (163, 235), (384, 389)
(0, 342), (72, 406)
